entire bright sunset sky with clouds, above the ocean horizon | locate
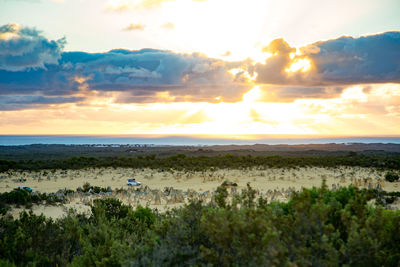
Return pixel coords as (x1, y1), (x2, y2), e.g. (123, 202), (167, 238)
(0, 0), (400, 136)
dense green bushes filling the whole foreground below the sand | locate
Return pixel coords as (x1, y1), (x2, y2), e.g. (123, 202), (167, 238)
(0, 185), (400, 266)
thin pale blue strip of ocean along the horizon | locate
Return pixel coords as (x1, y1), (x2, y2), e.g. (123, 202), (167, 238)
(0, 135), (400, 146)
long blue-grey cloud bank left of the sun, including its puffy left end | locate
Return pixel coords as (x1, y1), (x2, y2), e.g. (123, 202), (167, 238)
(0, 24), (250, 110)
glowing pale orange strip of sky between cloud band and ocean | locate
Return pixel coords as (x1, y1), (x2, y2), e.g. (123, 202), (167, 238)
(0, 84), (400, 135)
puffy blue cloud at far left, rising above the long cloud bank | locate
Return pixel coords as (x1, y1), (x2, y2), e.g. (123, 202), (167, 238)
(0, 23), (65, 71)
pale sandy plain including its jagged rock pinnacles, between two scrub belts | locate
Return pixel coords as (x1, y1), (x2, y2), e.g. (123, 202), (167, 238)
(0, 166), (400, 218)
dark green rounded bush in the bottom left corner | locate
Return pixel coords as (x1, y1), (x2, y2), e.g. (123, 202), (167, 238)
(0, 212), (74, 266)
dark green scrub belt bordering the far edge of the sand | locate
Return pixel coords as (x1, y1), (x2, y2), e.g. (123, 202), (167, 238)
(0, 152), (400, 172)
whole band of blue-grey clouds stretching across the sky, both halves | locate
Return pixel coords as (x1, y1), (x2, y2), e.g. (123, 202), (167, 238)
(0, 23), (400, 109)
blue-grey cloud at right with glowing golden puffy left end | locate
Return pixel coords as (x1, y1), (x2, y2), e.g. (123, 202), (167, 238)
(255, 32), (400, 86)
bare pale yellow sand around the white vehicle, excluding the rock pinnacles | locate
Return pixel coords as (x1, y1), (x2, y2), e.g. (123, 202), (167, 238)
(0, 167), (400, 218)
